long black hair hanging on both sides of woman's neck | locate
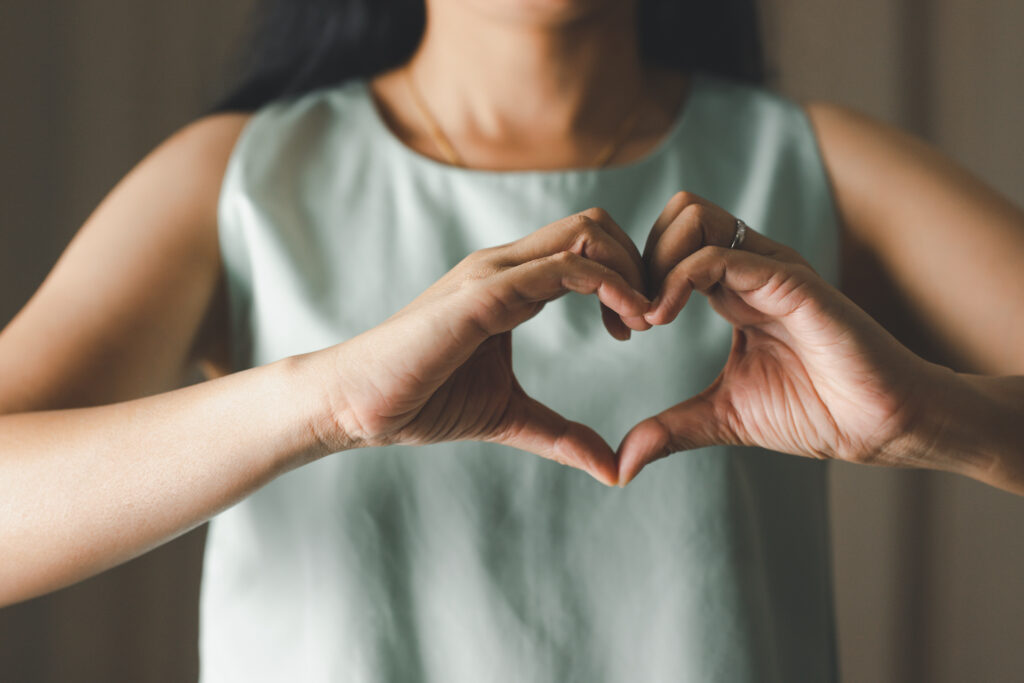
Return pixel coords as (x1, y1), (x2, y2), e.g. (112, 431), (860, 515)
(207, 0), (765, 114)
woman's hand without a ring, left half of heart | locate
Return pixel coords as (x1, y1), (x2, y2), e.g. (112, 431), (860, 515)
(322, 209), (650, 485)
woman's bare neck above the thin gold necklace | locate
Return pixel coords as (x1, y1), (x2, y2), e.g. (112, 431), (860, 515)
(408, 1), (645, 144)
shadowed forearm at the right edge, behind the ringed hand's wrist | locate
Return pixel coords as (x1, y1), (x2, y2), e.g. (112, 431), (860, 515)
(911, 370), (1024, 495)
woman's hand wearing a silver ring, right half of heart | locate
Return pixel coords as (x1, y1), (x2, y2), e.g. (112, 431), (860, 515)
(618, 193), (955, 485)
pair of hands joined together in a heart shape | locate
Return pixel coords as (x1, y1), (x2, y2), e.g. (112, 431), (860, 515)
(317, 193), (943, 485)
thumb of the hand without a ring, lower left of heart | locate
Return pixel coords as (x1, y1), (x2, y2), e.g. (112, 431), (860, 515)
(490, 394), (618, 486)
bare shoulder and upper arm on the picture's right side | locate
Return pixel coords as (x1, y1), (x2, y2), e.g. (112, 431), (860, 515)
(805, 102), (1024, 373)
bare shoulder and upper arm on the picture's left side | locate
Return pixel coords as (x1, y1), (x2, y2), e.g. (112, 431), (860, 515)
(0, 113), (251, 413)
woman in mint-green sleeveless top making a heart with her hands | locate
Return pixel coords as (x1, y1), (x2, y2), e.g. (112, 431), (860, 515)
(0, 0), (1024, 681)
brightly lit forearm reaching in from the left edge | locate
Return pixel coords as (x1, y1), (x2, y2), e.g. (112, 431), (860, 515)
(0, 354), (330, 604)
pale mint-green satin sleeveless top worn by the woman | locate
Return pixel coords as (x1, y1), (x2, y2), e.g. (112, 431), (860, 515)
(200, 74), (838, 683)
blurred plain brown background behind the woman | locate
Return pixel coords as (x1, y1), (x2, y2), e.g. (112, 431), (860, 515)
(0, 0), (1024, 683)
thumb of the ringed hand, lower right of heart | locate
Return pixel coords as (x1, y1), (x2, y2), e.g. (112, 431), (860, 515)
(618, 393), (733, 486)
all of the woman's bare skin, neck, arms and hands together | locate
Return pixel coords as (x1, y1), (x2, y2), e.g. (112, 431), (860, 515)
(0, 0), (1024, 604)
